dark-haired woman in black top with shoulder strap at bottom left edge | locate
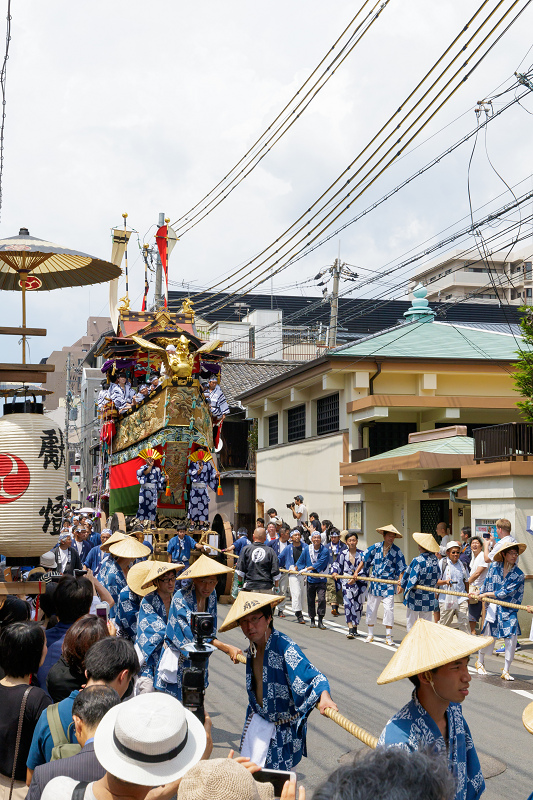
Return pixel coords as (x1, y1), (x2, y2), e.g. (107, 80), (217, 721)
(0, 622), (51, 800)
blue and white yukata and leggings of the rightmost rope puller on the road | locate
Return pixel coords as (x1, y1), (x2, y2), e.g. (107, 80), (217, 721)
(479, 561), (525, 673)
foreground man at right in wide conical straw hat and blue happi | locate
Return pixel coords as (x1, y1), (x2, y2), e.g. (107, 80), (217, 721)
(377, 619), (493, 800)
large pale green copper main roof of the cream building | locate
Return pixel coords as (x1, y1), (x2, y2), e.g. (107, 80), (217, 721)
(330, 317), (529, 361)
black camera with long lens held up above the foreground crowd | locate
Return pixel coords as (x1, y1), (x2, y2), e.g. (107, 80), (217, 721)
(180, 611), (215, 725)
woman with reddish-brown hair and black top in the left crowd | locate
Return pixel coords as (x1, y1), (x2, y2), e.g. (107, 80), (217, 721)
(46, 614), (109, 703)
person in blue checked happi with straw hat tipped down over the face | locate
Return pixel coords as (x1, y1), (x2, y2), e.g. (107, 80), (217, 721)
(402, 533), (438, 633)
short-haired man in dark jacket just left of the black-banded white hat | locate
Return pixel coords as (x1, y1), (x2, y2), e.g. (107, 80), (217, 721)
(26, 684), (120, 800)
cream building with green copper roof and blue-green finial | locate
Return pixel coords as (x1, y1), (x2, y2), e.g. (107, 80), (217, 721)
(238, 289), (533, 557)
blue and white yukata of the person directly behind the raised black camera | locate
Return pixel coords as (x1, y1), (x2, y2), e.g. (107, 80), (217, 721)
(154, 584), (217, 701)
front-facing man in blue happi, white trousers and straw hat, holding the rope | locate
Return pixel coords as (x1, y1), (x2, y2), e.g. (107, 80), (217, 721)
(355, 525), (407, 646)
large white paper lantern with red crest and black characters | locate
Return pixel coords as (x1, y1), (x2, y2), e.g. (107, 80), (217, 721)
(0, 413), (65, 558)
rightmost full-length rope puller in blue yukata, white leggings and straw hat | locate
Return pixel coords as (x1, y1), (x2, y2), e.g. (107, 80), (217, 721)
(472, 542), (533, 681)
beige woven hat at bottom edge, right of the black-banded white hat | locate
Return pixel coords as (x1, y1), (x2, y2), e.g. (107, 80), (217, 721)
(179, 758), (274, 800)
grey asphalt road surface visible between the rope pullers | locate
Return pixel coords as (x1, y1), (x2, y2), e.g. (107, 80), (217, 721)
(206, 605), (533, 800)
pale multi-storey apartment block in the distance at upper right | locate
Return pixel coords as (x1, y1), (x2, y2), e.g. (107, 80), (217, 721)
(407, 249), (533, 304)
